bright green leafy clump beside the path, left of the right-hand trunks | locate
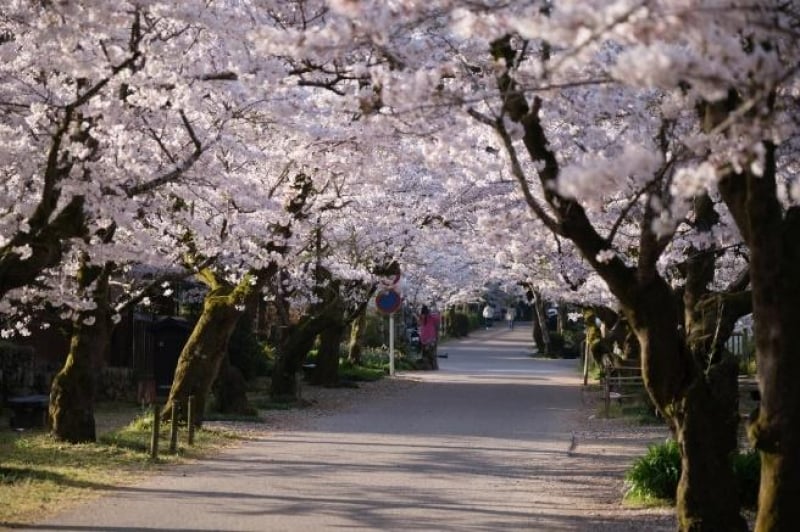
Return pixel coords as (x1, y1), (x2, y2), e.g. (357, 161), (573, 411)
(625, 440), (681, 502)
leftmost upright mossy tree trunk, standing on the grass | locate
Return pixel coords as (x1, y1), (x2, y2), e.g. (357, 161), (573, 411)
(49, 262), (113, 443)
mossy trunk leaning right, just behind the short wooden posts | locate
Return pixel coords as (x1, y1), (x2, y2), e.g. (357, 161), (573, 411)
(162, 272), (246, 426)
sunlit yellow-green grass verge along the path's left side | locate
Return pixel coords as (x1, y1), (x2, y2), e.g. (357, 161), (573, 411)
(0, 405), (242, 526)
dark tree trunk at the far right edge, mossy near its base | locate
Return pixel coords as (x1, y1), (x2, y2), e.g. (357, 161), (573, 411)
(720, 142), (800, 532)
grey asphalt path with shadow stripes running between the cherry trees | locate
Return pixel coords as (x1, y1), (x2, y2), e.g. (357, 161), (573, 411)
(15, 324), (672, 532)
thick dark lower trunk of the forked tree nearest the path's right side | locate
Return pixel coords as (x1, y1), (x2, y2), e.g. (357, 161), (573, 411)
(626, 279), (747, 532)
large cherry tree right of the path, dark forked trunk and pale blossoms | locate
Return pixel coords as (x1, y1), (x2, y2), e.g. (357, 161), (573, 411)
(247, 2), (792, 530)
